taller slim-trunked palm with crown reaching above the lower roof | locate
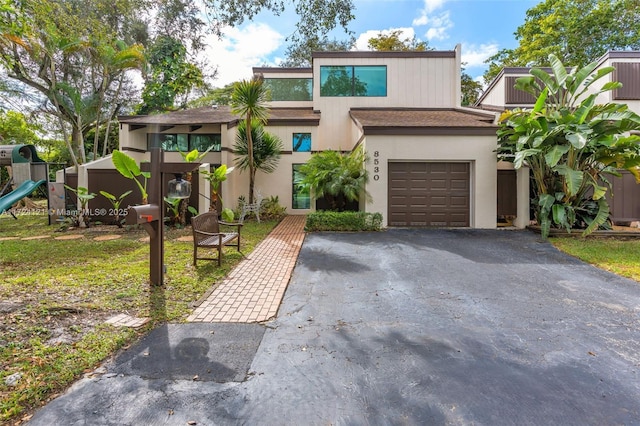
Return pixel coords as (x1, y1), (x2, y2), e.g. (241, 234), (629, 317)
(231, 75), (269, 204)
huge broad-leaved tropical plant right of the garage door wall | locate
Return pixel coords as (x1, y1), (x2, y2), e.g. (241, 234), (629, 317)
(497, 55), (640, 237)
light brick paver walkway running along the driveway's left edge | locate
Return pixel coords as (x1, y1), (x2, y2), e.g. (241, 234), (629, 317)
(187, 216), (306, 322)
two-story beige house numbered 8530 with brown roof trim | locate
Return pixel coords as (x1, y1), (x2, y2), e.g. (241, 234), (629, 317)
(78, 46), (510, 228)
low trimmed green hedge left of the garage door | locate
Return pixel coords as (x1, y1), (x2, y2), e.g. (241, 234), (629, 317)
(305, 211), (382, 232)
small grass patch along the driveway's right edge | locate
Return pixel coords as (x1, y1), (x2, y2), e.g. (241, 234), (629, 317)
(549, 237), (640, 282)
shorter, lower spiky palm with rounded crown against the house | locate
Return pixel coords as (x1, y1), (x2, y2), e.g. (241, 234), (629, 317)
(233, 120), (284, 204)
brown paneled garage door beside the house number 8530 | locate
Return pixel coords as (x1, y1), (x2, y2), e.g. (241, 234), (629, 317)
(388, 162), (470, 227)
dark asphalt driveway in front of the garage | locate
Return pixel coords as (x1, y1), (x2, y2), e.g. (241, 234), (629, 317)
(31, 229), (640, 425)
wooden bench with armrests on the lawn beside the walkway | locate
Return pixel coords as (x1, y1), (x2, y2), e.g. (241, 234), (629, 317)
(191, 210), (242, 266)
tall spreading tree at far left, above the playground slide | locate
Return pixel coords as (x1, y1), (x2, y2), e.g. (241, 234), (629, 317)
(0, 0), (142, 166)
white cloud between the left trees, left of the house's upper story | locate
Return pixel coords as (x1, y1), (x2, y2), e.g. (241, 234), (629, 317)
(205, 23), (284, 87)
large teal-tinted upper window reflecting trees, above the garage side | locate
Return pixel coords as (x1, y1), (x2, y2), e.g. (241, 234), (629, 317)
(320, 65), (387, 96)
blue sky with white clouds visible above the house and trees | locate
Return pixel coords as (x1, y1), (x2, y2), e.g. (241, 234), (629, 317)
(207, 0), (539, 87)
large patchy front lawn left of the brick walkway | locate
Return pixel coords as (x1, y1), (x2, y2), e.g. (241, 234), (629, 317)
(0, 214), (277, 423)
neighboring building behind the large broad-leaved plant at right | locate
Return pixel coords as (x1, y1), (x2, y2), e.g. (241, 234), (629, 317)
(474, 51), (640, 222)
